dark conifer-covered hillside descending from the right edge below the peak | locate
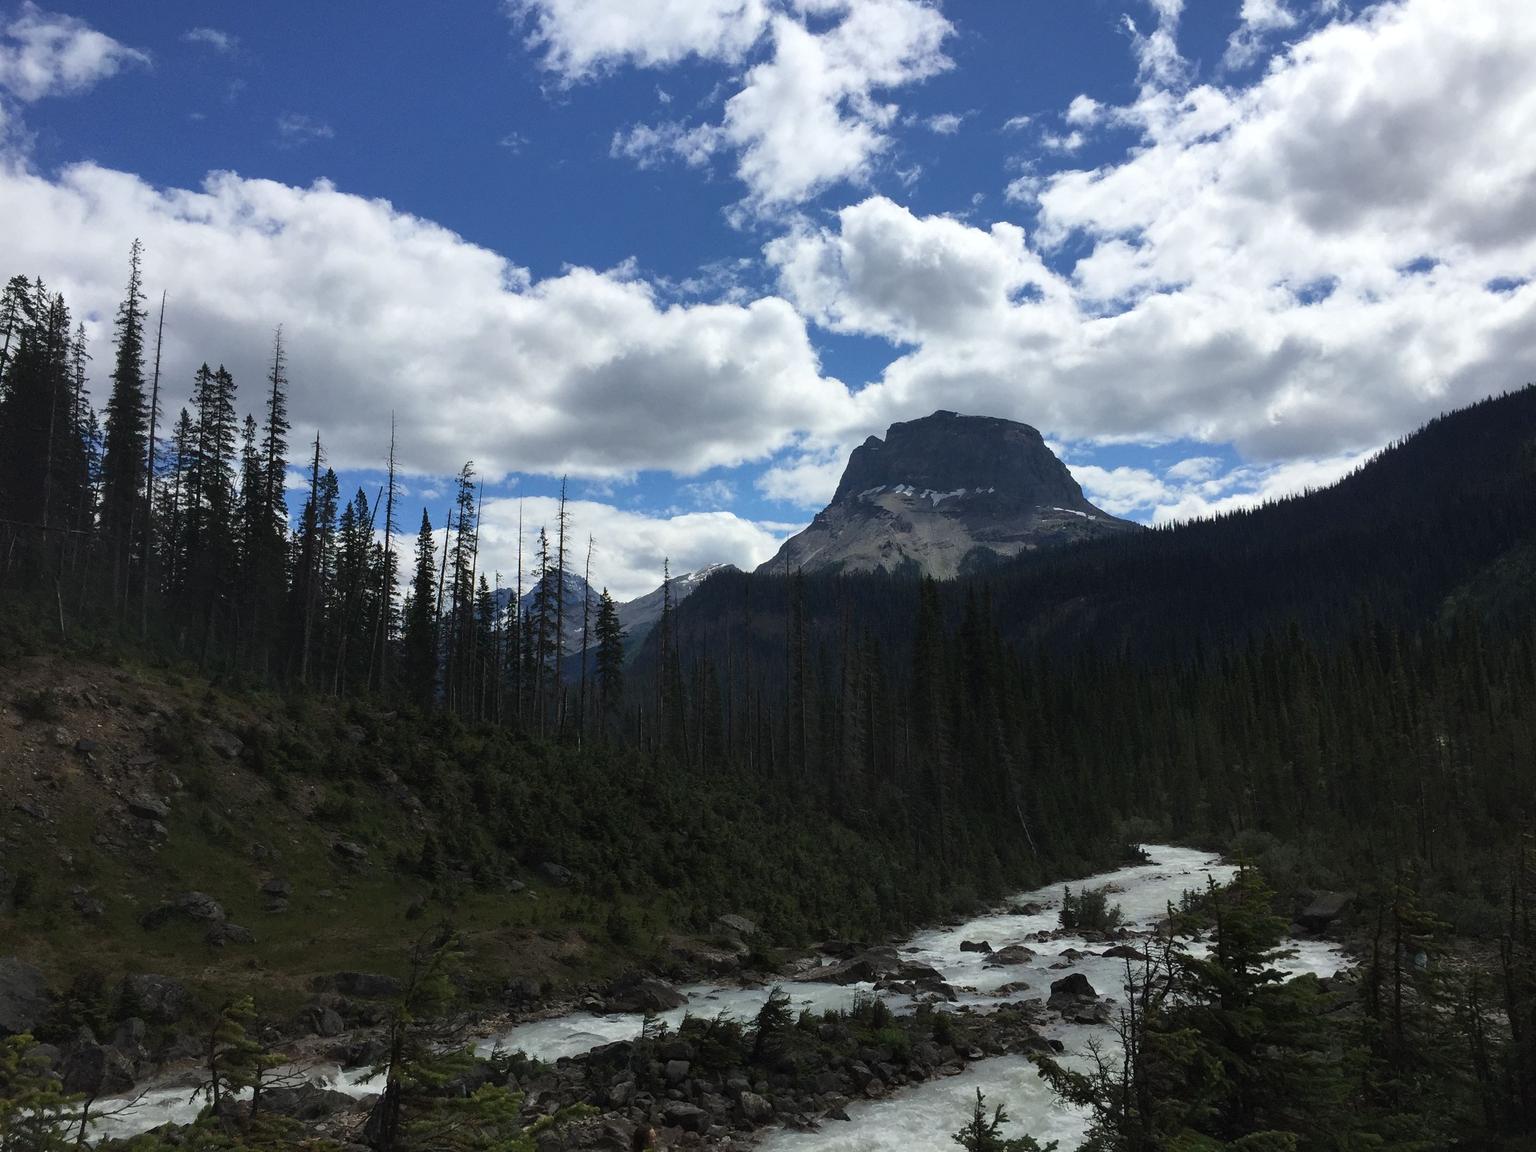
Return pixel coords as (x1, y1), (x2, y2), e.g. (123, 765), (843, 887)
(647, 387), (1536, 921)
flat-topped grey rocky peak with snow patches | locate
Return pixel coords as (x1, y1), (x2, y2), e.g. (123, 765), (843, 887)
(759, 412), (1140, 579)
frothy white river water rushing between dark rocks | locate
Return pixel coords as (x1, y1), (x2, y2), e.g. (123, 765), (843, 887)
(94, 845), (1346, 1152)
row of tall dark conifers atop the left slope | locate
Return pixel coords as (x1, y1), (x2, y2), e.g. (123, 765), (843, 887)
(0, 241), (625, 736)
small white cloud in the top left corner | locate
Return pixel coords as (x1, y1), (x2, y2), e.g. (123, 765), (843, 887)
(0, 0), (149, 103)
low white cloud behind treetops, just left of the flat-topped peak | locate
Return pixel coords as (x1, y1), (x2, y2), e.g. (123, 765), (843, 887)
(479, 496), (794, 601)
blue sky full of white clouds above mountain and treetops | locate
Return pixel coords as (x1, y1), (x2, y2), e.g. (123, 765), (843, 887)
(0, 0), (1536, 594)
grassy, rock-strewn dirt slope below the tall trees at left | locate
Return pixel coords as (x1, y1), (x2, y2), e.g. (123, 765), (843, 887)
(0, 657), (670, 1011)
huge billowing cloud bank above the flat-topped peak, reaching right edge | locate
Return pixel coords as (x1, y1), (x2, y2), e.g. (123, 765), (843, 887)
(766, 0), (1536, 499)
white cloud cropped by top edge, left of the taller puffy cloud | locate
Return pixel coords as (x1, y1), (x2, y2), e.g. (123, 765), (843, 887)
(507, 0), (768, 81)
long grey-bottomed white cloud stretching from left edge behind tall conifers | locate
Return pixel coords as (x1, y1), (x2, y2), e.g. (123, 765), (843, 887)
(0, 158), (849, 476)
